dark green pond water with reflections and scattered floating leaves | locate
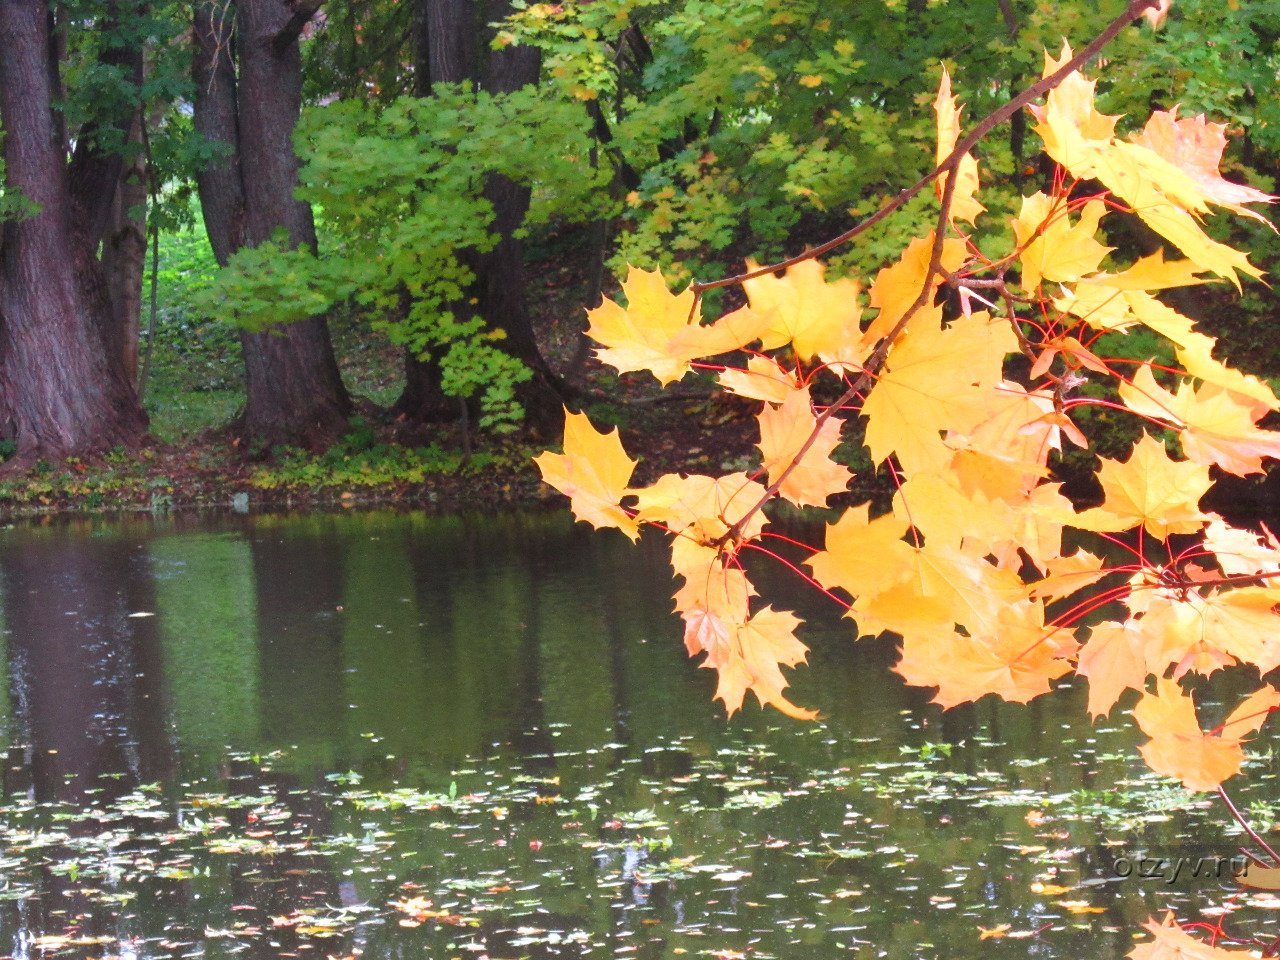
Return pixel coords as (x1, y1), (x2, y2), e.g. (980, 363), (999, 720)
(0, 511), (1280, 960)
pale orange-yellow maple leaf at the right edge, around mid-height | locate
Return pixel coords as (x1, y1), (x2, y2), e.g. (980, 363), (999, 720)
(1119, 365), (1280, 476)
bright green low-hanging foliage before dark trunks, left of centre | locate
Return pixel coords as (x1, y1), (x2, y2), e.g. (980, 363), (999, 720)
(196, 86), (598, 431)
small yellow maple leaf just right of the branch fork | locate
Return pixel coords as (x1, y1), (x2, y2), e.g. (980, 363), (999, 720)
(1012, 192), (1112, 291)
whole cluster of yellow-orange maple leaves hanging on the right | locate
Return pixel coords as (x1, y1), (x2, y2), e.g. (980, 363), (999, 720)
(538, 49), (1280, 798)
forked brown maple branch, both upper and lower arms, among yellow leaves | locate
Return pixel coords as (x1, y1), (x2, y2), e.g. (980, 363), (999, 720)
(711, 0), (1157, 547)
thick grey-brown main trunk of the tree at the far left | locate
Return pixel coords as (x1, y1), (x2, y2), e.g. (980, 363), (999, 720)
(0, 0), (147, 462)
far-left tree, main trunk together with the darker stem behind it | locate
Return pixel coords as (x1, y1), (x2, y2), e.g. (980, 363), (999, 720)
(0, 0), (147, 462)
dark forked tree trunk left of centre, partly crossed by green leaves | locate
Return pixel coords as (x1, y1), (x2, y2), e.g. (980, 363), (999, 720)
(193, 0), (351, 448)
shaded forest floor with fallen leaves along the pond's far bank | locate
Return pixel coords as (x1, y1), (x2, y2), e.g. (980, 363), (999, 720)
(0, 234), (1280, 518)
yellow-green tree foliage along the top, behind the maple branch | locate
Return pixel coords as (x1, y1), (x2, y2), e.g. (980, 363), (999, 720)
(499, 0), (1280, 285)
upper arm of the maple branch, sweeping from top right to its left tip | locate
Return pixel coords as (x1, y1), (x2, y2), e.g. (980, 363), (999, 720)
(690, 0), (1158, 294)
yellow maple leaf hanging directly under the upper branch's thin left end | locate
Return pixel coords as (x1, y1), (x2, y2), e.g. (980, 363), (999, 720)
(742, 260), (868, 361)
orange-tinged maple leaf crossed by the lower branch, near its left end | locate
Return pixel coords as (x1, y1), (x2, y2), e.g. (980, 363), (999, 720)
(759, 387), (852, 507)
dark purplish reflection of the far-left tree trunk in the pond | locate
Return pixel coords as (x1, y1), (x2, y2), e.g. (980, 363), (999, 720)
(0, 525), (174, 957)
